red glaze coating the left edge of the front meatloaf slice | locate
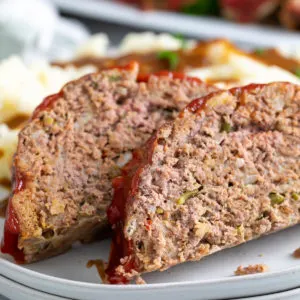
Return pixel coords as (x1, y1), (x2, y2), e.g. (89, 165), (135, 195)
(105, 136), (156, 284)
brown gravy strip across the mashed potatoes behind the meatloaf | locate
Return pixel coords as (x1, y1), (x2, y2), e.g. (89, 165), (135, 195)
(54, 40), (300, 77)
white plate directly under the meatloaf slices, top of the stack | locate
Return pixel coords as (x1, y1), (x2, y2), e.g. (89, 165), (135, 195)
(0, 219), (300, 300)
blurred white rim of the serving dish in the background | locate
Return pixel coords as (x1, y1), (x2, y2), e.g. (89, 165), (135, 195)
(52, 0), (300, 46)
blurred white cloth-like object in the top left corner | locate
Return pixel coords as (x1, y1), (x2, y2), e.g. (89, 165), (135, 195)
(0, 0), (90, 62)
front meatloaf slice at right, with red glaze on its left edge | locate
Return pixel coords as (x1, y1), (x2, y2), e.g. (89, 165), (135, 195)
(106, 83), (300, 283)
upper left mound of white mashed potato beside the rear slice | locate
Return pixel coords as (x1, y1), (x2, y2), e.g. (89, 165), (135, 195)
(0, 56), (95, 124)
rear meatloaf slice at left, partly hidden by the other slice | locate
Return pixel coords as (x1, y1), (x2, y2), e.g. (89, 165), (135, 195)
(2, 63), (215, 263)
